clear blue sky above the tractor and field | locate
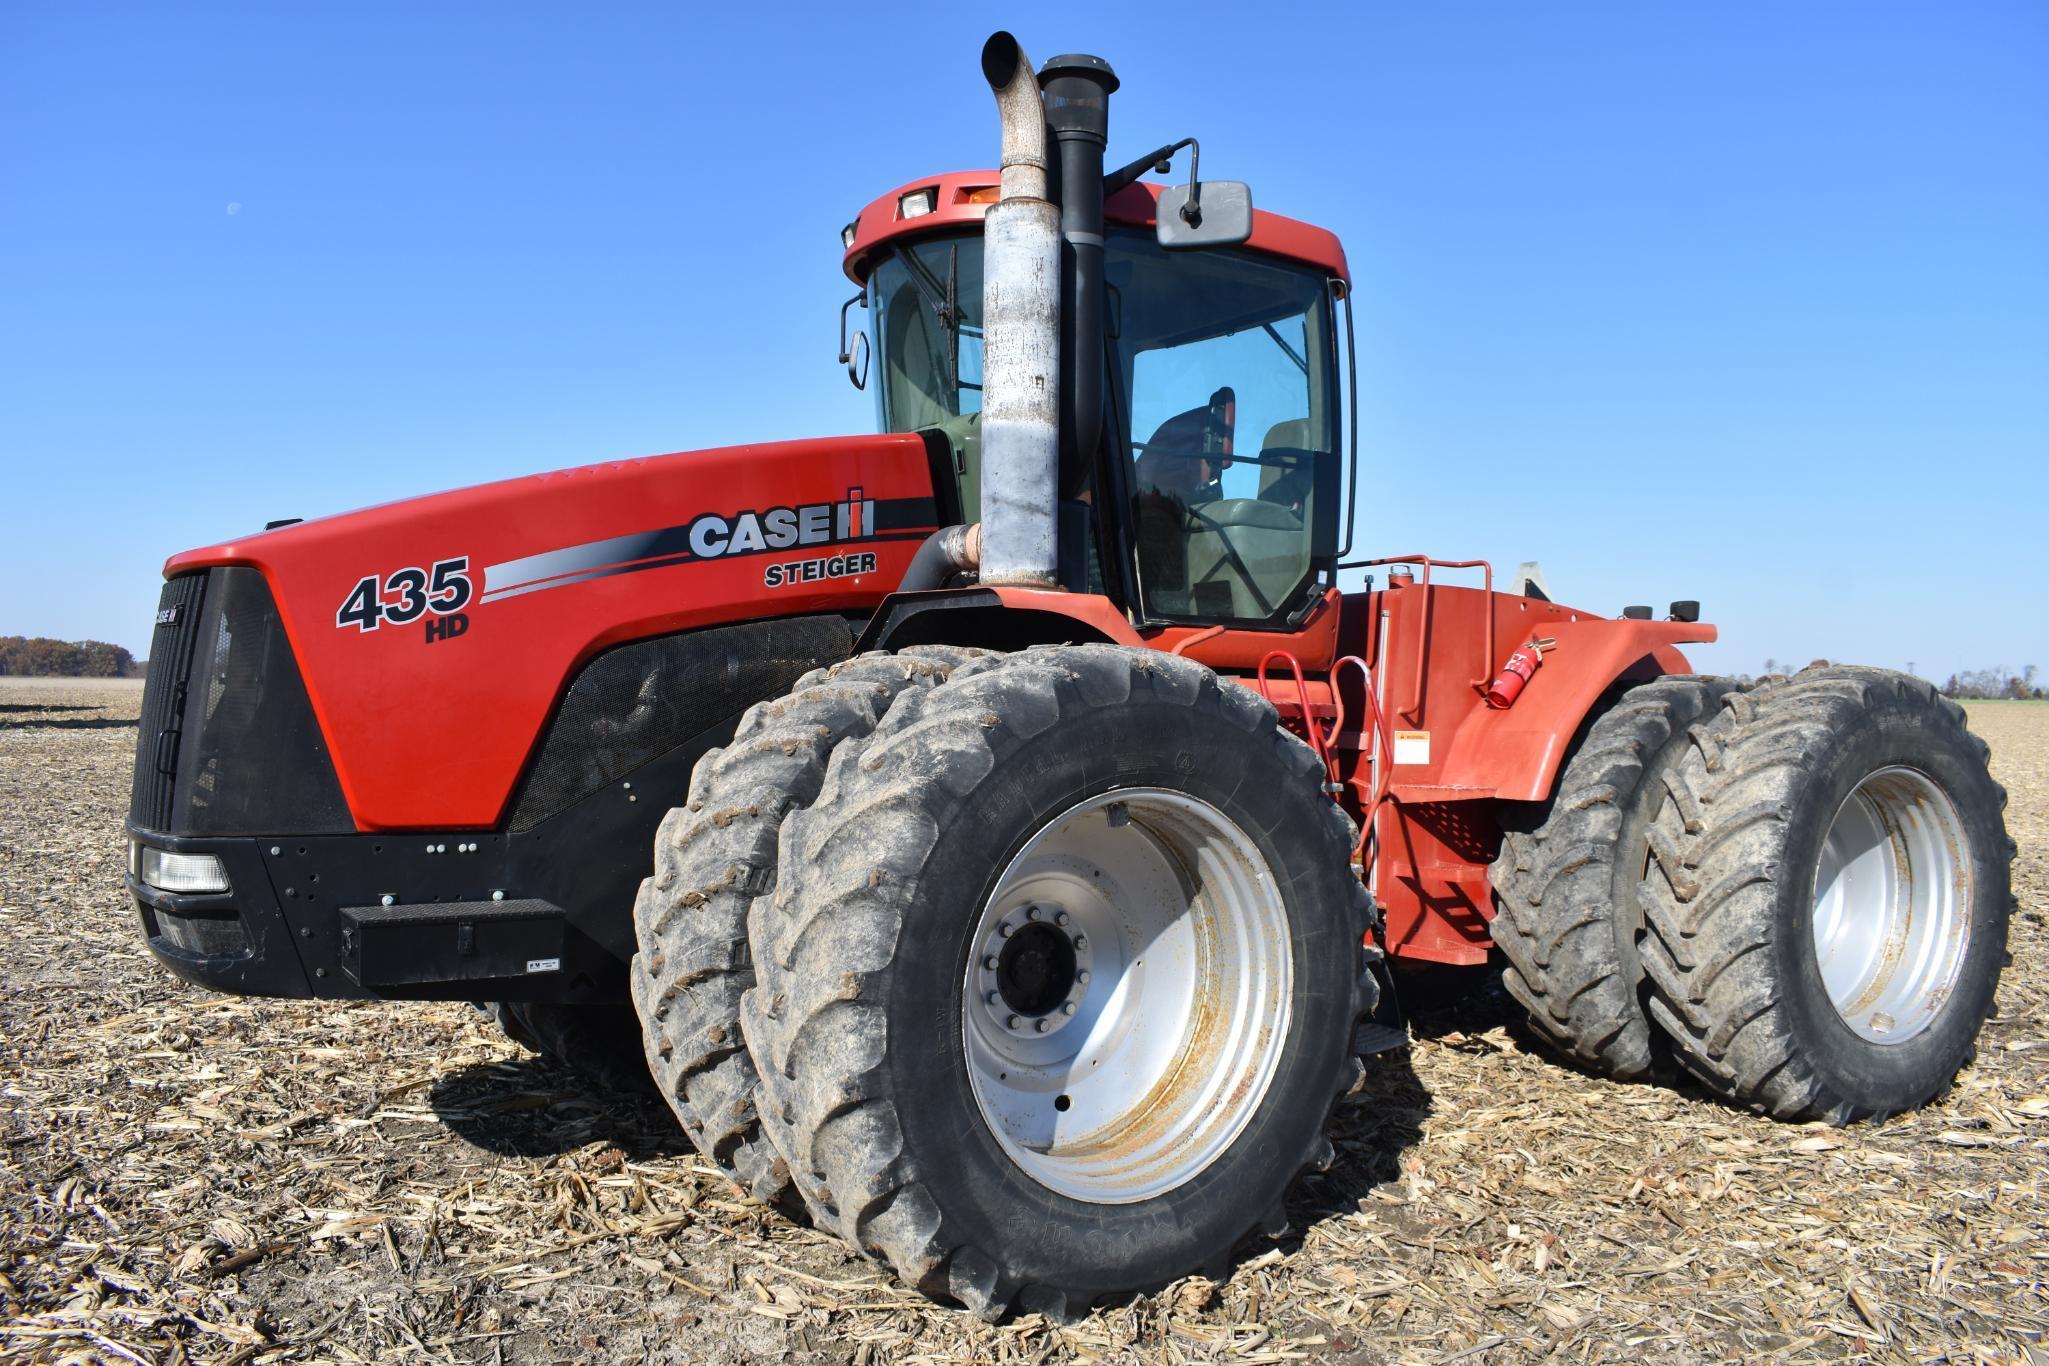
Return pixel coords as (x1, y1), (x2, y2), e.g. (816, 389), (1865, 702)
(0, 2), (2049, 676)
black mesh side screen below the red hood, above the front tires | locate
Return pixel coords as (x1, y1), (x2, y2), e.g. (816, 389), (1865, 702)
(512, 616), (854, 829)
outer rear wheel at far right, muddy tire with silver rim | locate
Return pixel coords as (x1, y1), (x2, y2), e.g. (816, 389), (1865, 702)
(1641, 668), (2014, 1124)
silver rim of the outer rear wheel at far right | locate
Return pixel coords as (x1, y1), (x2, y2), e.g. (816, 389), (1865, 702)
(1813, 768), (1971, 1044)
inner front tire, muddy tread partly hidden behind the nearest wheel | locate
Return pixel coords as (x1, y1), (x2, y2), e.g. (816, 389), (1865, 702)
(631, 645), (977, 1200)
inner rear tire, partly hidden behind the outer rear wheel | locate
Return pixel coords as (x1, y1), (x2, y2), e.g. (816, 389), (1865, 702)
(1492, 676), (1733, 1081)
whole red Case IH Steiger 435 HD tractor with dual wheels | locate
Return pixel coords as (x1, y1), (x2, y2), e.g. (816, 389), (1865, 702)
(129, 33), (2012, 1315)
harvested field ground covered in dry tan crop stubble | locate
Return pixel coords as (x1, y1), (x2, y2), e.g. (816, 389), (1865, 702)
(0, 680), (2049, 1362)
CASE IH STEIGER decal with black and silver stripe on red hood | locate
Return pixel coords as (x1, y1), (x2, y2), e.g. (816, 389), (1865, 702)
(469, 487), (938, 602)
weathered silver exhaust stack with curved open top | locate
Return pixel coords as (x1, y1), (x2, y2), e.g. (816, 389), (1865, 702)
(981, 33), (1059, 588)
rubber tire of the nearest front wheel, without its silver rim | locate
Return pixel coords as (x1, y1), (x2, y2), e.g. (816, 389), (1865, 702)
(744, 645), (1373, 1317)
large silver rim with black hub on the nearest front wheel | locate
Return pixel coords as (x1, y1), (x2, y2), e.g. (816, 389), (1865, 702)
(961, 788), (1295, 1204)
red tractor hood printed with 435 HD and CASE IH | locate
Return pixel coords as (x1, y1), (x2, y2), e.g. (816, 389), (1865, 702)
(164, 434), (951, 829)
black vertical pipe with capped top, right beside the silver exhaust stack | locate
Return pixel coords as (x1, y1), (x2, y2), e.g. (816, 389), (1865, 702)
(1039, 53), (1117, 498)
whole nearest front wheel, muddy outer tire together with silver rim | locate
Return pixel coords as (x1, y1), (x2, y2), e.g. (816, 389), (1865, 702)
(641, 645), (1373, 1317)
